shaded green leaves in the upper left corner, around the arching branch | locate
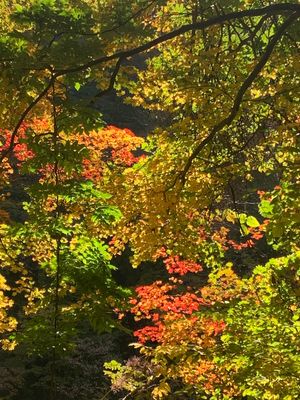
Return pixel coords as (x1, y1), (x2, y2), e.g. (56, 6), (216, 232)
(0, 0), (159, 135)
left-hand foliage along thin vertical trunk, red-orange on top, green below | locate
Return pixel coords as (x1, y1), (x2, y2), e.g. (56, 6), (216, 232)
(1, 120), (144, 353)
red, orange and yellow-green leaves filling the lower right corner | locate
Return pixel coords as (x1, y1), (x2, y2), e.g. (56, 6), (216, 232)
(106, 202), (300, 399)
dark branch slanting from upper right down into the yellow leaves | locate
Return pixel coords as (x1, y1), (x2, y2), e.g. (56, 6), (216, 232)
(177, 13), (299, 186)
